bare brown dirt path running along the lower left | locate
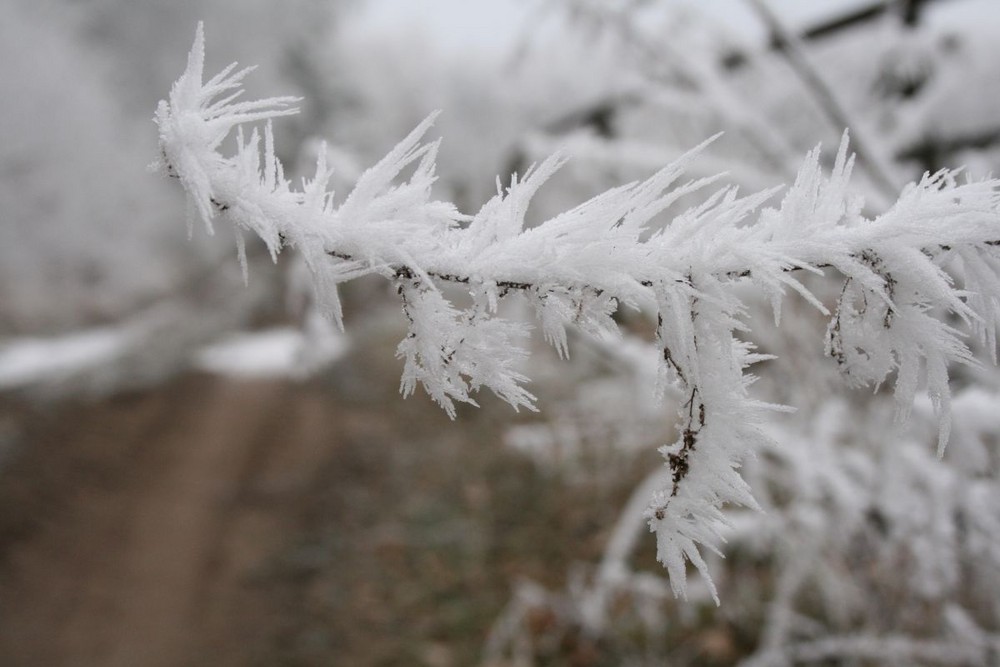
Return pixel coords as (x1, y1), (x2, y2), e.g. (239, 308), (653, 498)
(0, 378), (340, 667)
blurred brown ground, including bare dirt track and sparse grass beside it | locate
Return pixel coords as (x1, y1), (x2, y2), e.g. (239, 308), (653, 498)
(0, 368), (648, 667)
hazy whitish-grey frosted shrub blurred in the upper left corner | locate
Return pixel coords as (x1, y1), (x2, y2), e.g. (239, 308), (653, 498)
(0, 2), (190, 336)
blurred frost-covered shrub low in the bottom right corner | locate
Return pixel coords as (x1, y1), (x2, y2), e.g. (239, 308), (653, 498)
(486, 387), (1000, 666)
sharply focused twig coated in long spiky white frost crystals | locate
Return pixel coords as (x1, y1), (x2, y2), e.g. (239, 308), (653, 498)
(156, 27), (1000, 593)
